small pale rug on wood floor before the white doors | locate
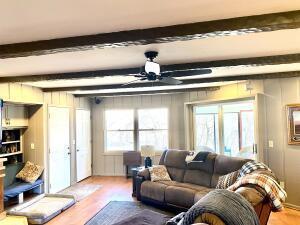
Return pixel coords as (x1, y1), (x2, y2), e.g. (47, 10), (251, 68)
(59, 183), (101, 202)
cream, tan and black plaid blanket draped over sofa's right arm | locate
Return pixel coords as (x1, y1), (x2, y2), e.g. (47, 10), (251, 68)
(227, 172), (287, 211)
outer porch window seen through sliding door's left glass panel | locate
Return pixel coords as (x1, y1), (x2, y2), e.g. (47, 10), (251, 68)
(195, 114), (219, 152)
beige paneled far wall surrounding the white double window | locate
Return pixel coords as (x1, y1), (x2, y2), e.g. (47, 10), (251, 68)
(92, 94), (185, 176)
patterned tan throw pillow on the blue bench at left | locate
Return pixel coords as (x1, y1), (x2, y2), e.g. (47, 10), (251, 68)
(16, 161), (44, 183)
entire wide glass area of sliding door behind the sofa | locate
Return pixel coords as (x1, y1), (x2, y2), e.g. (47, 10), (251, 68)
(193, 100), (256, 158)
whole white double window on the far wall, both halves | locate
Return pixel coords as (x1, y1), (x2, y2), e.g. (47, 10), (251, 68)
(105, 108), (169, 152)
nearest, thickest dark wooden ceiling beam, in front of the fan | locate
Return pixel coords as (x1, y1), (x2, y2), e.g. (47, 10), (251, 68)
(0, 10), (300, 59)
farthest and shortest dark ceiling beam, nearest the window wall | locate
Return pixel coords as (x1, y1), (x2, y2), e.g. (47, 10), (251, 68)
(75, 86), (220, 97)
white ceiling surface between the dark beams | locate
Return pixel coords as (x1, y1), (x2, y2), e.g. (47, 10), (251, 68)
(0, 0), (300, 93)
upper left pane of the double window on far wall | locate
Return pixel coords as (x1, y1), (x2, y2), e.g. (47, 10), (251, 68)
(105, 110), (134, 130)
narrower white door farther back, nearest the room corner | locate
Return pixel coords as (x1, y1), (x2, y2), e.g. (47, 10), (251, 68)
(76, 109), (92, 182)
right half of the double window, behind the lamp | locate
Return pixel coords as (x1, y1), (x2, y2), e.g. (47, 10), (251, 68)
(138, 108), (169, 150)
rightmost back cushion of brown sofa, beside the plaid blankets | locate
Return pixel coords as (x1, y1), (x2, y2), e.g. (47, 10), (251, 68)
(211, 155), (251, 187)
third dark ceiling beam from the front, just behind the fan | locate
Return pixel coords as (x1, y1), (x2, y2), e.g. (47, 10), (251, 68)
(69, 71), (300, 96)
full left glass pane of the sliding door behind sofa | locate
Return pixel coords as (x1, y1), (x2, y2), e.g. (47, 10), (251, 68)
(194, 106), (219, 152)
